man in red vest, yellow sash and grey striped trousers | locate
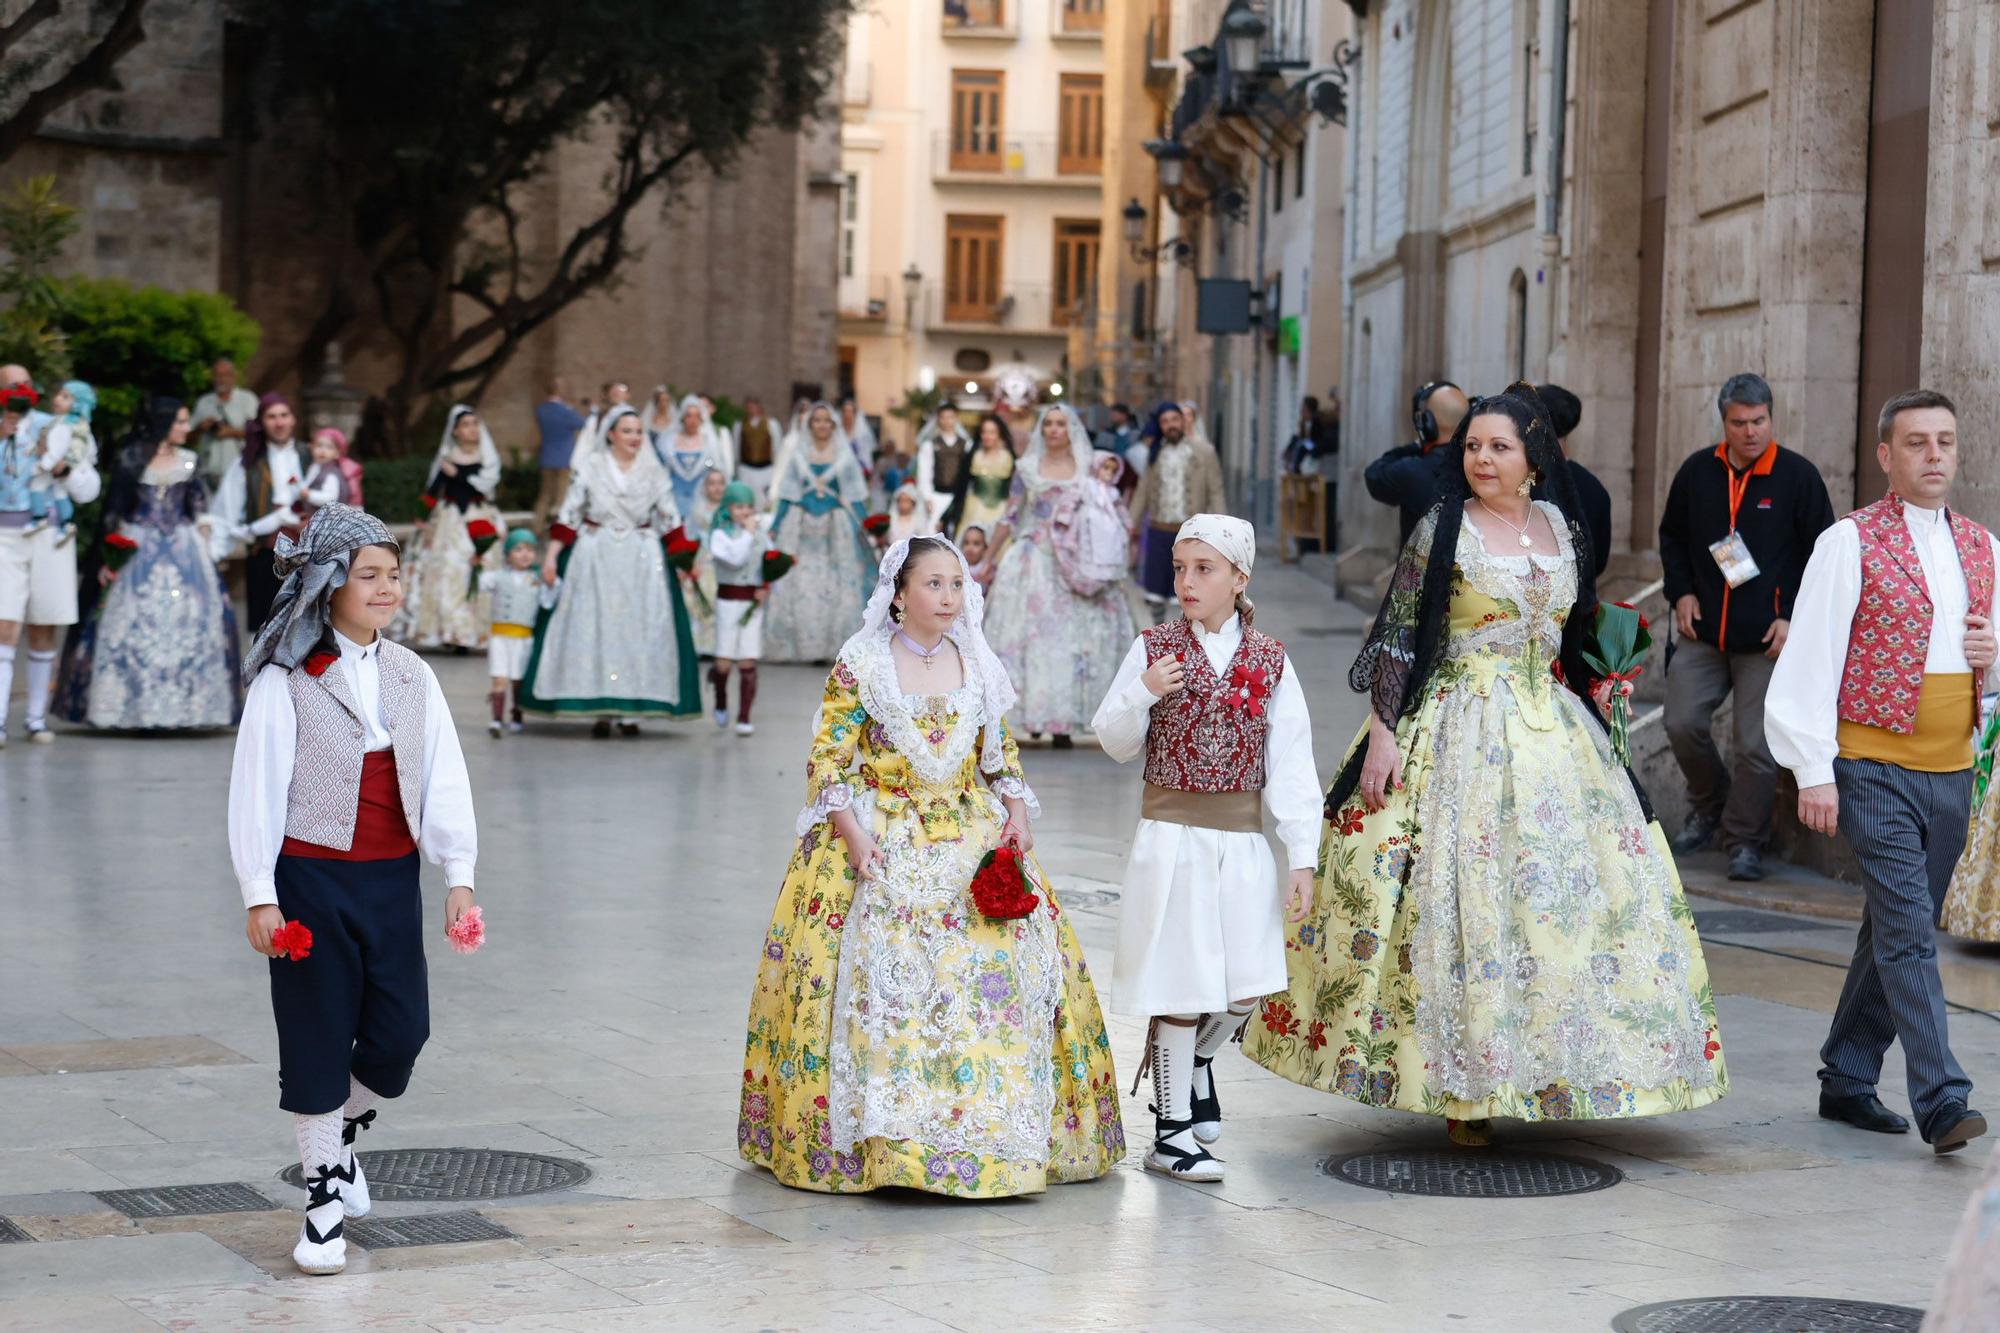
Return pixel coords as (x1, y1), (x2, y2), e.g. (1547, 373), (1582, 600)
(1764, 388), (2000, 1153)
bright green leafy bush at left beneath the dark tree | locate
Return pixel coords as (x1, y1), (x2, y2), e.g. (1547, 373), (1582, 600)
(56, 278), (264, 438)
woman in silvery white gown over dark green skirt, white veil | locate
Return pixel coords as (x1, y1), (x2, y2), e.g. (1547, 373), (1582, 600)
(520, 404), (702, 739)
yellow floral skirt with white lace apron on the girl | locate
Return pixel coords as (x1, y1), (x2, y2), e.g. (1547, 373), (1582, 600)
(736, 791), (1124, 1199)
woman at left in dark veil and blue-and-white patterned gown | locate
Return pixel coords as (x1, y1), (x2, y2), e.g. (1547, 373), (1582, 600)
(56, 398), (242, 731)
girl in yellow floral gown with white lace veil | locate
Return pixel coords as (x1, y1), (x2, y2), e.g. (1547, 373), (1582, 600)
(736, 536), (1124, 1199)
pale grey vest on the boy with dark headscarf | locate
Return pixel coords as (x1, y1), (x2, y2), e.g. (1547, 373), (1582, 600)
(284, 638), (430, 851)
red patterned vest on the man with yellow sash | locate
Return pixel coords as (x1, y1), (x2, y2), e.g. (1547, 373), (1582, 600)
(1840, 494), (1994, 737)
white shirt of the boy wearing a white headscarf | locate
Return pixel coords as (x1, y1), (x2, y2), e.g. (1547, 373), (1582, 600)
(1090, 616), (1324, 871)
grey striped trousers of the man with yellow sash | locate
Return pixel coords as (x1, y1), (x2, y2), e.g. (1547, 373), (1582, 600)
(1820, 759), (1972, 1139)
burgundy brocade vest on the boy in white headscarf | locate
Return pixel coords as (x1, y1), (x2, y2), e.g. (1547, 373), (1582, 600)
(1140, 618), (1284, 793)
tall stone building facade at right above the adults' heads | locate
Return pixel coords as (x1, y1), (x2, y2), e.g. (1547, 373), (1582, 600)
(1342, 0), (2000, 586)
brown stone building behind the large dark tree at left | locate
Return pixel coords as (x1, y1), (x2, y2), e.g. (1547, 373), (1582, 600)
(0, 0), (840, 450)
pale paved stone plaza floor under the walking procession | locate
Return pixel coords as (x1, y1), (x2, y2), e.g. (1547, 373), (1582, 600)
(0, 564), (2000, 1333)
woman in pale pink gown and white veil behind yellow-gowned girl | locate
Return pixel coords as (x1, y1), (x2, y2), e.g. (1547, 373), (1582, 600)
(990, 406), (1134, 749)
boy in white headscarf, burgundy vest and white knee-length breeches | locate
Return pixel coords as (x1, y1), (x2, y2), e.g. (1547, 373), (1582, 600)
(1092, 514), (1320, 1181)
